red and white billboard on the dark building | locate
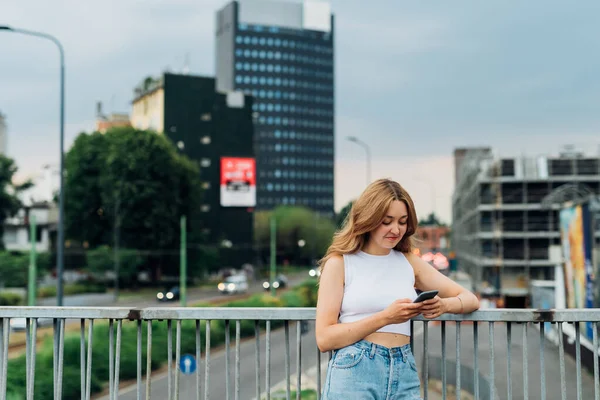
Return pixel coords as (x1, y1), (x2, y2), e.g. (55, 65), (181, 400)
(221, 157), (256, 207)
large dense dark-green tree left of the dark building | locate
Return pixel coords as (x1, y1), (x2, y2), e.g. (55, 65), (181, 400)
(65, 127), (201, 276)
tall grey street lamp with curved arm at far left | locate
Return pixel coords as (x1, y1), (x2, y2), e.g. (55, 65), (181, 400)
(0, 25), (65, 307)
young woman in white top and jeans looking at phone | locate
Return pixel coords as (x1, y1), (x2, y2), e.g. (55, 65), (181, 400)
(316, 179), (479, 400)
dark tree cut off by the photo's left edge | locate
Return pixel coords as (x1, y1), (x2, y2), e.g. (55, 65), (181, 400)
(0, 155), (32, 249)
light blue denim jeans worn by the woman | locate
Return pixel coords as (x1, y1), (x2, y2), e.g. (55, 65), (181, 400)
(322, 340), (421, 400)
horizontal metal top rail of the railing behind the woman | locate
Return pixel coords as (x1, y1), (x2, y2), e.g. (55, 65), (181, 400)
(0, 307), (600, 322)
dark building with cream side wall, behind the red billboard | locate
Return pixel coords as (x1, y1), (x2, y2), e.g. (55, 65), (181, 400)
(132, 74), (254, 268)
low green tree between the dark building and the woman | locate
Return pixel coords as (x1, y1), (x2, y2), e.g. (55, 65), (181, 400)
(254, 206), (335, 263)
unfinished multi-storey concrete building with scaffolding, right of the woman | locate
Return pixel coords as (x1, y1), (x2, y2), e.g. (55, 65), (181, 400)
(452, 148), (600, 307)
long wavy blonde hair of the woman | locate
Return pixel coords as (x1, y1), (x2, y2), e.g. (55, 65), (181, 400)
(319, 179), (418, 270)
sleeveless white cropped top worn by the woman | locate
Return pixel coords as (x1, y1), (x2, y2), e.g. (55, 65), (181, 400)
(338, 250), (417, 336)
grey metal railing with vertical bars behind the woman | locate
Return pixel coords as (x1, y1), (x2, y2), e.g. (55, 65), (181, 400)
(0, 307), (600, 400)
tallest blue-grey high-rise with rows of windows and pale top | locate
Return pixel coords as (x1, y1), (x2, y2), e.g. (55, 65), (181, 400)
(216, 0), (334, 215)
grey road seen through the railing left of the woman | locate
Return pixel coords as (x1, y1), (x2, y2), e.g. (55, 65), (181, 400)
(100, 322), (328, 400)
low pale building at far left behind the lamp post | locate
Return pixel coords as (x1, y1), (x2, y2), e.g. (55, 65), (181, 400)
(2, 202), (58, 252)
